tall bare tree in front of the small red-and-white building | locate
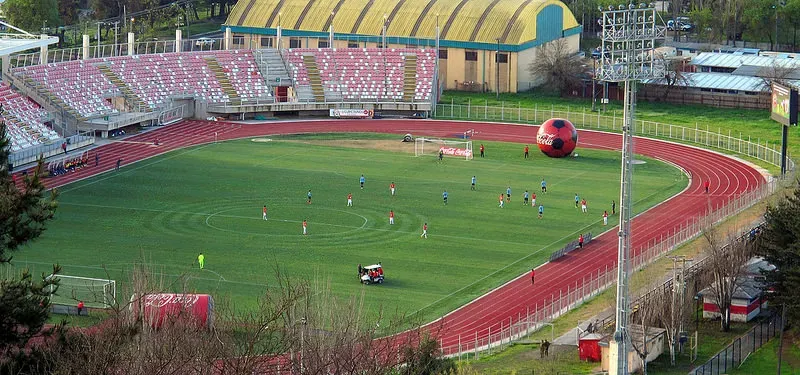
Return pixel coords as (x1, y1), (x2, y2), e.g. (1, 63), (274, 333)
(700, 228), (753, 332)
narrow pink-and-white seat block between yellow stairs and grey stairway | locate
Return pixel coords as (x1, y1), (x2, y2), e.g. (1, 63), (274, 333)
(216, 50), (272, 99)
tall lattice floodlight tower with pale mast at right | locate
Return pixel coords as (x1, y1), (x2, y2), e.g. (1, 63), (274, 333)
(599, 3), (665, 375)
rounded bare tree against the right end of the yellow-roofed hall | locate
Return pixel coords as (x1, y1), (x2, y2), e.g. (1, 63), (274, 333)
(528, 39), (587, 94)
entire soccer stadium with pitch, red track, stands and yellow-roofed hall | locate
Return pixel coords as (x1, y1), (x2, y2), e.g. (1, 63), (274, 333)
(0, 0), (793, 373)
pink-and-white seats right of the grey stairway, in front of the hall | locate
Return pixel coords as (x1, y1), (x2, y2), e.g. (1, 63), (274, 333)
(286, 48), (436, 101)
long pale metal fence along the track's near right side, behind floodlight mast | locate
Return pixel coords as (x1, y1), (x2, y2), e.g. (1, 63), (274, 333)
(441, 159), (782, 358)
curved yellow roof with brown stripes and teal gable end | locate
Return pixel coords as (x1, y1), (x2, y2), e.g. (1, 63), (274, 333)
(226, 0), (580, 45)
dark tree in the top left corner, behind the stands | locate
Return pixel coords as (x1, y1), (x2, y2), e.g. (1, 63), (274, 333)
(2, 0), (61, 34)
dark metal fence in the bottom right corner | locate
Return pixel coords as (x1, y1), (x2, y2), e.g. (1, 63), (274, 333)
(689, 314), (783, 375)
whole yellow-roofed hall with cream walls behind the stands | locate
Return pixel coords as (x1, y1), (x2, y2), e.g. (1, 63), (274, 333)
(223, 0), (582, 92)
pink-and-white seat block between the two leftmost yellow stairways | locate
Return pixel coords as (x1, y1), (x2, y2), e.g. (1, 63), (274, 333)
(14, 60), (116, 117)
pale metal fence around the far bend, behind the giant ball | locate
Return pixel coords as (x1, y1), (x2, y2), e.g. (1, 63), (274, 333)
(435, 104), (795, 174)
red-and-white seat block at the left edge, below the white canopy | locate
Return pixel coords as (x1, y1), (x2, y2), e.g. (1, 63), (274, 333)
(0, 83), (61, 152)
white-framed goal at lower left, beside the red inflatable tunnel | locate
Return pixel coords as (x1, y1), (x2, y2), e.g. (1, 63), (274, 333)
(47, 275), (117, 308)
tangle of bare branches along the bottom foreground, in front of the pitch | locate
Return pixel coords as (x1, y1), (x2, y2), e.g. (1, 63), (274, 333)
(34, 267), (428, 375)
